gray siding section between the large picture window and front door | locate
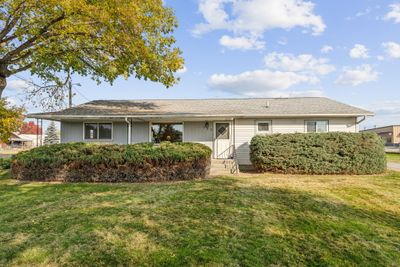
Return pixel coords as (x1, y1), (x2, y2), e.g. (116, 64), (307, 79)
(183, 122), (213, 149)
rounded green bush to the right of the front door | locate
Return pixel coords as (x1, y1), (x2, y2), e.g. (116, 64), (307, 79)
(250, 132), (386, 174)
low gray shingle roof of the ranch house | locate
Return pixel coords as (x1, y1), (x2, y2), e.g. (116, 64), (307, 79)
(28, 97), (373, 120)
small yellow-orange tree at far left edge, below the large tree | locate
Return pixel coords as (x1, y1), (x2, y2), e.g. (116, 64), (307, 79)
(0, 99), (24, 143)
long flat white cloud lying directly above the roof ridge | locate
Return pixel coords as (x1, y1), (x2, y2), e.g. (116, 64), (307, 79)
(209, 70), (318, 96)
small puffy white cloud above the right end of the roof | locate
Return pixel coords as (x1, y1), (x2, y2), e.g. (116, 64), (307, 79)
(336, 64), (379, 86)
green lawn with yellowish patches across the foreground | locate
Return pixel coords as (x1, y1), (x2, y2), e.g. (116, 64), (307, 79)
(0, 172), (400, 266)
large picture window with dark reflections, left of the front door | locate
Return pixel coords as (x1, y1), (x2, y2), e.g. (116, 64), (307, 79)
(151, 123), (183, 143)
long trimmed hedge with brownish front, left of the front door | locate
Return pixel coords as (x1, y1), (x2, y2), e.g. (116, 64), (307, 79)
(11, 143), (211, 182)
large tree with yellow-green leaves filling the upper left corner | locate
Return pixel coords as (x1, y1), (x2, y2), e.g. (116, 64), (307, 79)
(0, 0), (183, 107)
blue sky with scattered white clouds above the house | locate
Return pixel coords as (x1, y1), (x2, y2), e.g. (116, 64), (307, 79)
(5, 0), (400, 130)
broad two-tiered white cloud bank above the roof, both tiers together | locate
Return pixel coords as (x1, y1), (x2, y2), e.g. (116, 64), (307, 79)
(209, 52), (335, 97)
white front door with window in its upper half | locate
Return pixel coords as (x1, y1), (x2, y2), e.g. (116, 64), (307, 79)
(214, 122), (232, 159)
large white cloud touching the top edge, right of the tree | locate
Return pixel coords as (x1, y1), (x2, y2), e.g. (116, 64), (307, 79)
(192, 0), (326, 48)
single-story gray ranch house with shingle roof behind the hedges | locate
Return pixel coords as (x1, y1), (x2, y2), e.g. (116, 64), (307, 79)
(29, 97), (373, 169)
